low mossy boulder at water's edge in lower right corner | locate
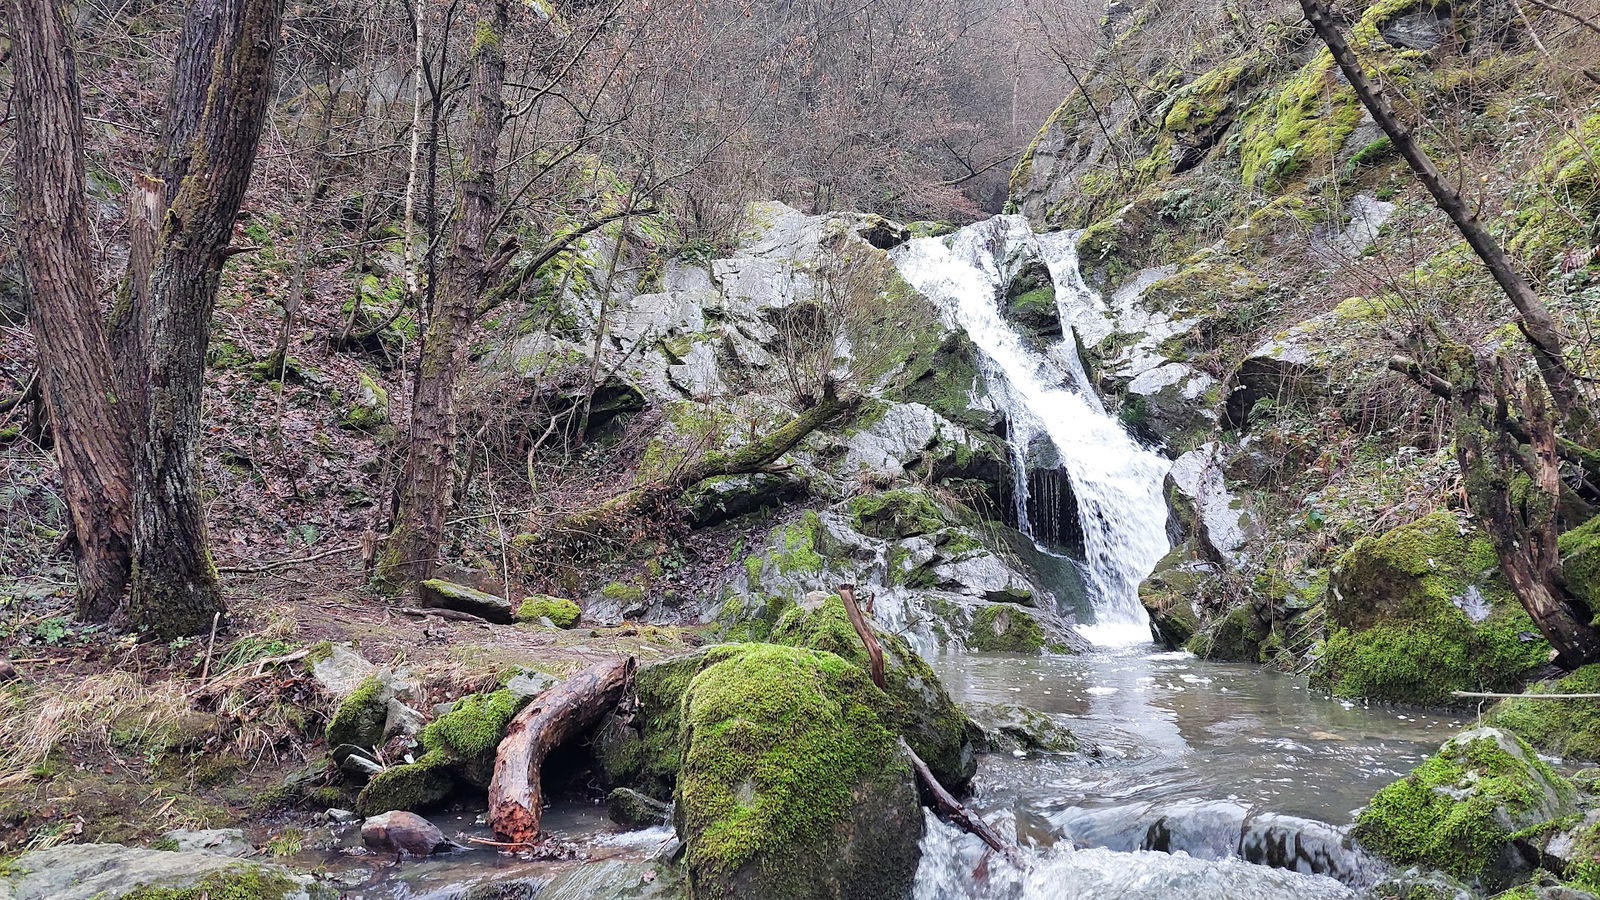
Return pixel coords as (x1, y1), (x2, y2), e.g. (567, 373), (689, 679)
(1355, 727), (1578, 889)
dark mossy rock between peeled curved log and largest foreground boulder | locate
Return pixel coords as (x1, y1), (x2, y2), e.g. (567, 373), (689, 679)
(594, 650), (706, 799)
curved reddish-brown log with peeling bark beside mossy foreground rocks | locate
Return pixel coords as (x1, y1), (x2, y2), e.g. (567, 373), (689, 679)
(490, 657), (634, 844)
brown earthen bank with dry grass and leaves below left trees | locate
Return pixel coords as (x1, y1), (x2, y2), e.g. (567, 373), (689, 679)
(0, 560), (704, 858)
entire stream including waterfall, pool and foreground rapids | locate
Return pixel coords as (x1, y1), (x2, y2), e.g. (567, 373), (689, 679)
(320, 216), (1461, 900)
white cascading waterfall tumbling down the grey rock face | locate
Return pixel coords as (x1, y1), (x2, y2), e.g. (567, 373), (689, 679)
(893, 216), (1168, 644)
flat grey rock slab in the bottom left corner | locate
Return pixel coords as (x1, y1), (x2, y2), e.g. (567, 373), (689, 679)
(0, 844), (328, 900)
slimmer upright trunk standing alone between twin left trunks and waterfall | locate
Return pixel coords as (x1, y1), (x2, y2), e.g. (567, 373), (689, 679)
(378, 0), (509, 589)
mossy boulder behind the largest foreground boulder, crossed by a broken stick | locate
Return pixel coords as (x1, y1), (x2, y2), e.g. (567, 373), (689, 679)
(770, 596), (981, 791)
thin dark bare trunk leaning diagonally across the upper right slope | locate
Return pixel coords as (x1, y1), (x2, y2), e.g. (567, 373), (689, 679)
(1301, 0), (1594, 444)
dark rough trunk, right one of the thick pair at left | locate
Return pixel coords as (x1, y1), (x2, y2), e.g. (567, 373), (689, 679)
(122, 0), (283, 637)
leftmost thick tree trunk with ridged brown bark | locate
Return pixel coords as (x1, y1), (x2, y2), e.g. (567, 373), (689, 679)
(8, 0), (131, 621)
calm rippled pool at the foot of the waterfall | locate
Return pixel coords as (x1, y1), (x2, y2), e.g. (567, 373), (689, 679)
(933, 645), (1461, 823)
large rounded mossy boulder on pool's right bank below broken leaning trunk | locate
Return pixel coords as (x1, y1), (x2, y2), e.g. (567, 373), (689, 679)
(1315, 512), (1550, 705)
